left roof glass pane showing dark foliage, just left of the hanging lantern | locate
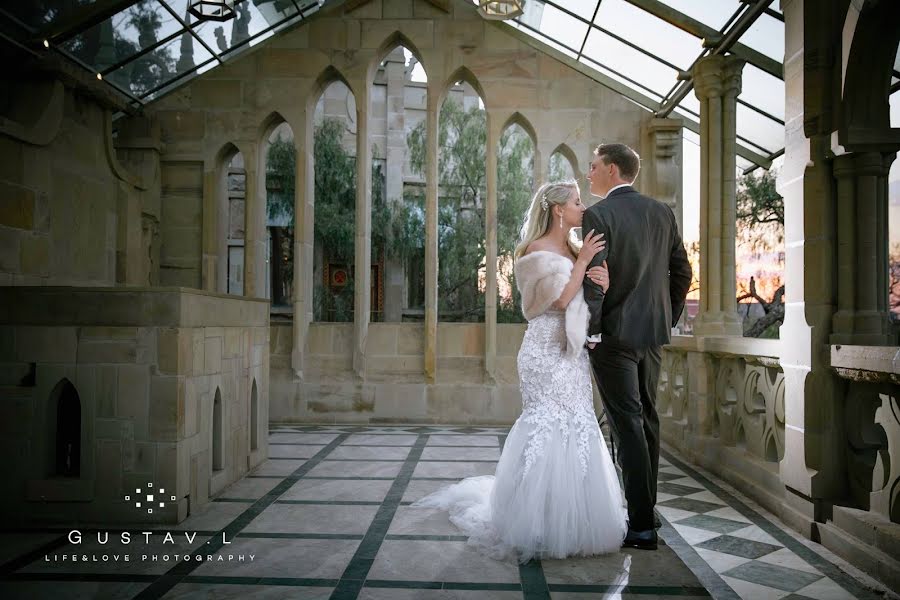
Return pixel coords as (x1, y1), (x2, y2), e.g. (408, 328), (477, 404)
(62, 0), (183, 71)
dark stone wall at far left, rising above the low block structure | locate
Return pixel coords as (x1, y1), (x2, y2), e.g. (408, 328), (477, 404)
(0, 76), (159, 286)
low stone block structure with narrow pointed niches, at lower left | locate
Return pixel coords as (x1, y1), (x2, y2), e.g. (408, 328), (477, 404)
(0, 287), (269, 524)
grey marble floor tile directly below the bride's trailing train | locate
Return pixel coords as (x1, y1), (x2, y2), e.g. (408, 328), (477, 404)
(368, 540), (519, 583)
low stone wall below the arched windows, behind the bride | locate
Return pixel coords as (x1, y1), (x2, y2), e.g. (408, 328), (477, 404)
(270, 323), (525, 425)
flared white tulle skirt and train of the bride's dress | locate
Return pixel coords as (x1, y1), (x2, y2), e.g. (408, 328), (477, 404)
(413, 412), (626, 563)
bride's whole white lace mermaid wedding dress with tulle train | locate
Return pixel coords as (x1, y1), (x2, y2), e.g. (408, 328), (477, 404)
(413, 274), (626, 562)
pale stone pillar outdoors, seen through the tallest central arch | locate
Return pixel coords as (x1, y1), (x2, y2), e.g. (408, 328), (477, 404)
(384, 48), (406, 322)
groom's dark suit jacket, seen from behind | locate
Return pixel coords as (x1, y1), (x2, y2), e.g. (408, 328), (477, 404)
(581, 186), (691, 349)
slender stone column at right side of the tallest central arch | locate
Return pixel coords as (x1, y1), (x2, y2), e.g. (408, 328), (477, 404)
(425, 84), (441, 383)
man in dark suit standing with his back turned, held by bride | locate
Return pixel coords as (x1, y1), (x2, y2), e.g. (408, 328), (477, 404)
(581, 144), (691, 550)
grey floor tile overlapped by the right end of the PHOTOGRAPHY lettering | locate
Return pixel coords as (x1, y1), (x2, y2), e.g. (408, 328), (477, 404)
(192, 537), (359, 580)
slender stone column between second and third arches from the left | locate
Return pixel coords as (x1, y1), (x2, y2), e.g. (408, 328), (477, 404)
(291, 111), (315, 381)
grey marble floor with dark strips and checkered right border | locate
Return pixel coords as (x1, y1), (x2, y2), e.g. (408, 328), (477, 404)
(0, 425), (882, 600)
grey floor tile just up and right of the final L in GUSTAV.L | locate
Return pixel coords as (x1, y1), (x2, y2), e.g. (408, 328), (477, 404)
(242, 504), (378, 535)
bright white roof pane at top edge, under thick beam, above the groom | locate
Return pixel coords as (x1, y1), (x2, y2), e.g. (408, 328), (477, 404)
(594, 0), (703, 69)
